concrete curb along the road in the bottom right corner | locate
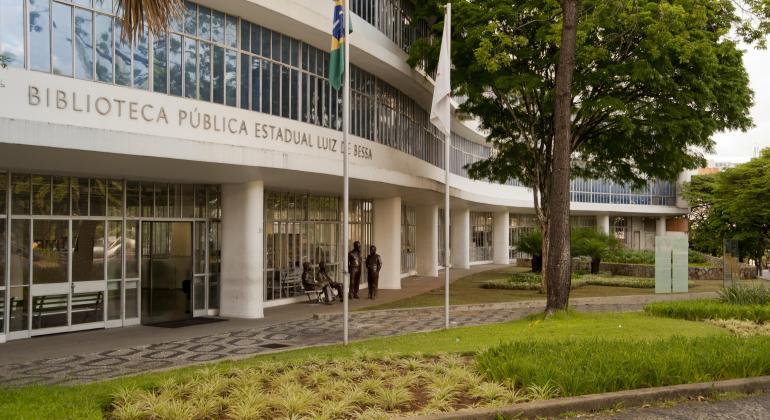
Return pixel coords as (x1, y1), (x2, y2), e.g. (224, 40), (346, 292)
(409, 376), (770, 420)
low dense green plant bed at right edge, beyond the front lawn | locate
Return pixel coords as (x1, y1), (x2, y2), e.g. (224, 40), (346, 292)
(644, 300), (770, 323)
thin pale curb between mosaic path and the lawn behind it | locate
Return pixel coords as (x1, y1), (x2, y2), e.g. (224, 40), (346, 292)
(313, 292), (717, 319)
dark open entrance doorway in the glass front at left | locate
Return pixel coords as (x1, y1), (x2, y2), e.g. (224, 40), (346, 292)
(142, 222), (194, 324)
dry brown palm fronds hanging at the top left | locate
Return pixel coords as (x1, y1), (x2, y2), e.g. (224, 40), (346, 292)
(118, 0), (183, 41)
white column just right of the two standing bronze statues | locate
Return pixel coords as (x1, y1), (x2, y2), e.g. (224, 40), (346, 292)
(372, 197), (402, 289)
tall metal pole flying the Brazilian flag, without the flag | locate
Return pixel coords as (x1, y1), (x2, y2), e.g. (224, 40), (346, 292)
(342, 0), (350, 345)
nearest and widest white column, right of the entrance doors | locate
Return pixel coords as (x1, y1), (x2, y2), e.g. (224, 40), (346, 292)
(220, 181), (265, 318)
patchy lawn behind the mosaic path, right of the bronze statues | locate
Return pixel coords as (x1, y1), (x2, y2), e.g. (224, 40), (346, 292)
(360, 267), (722, 311)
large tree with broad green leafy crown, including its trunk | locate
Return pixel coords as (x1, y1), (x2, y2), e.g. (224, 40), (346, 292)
(410, 0), (762, 308)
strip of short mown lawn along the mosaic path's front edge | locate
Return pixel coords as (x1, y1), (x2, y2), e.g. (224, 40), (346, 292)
(0, 313), (727, 419)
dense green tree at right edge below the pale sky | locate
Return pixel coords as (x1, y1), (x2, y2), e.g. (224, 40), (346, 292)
(684, 149), (770, 274)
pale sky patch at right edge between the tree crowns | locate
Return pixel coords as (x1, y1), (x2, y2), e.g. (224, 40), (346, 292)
(708, 47), (770, 163)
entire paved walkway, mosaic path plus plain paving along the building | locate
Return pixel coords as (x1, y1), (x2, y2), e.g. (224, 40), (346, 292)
(0, 266), (716, 387)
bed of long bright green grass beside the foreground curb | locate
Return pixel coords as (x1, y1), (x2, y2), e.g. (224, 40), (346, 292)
(476, 335), (770, 396)
